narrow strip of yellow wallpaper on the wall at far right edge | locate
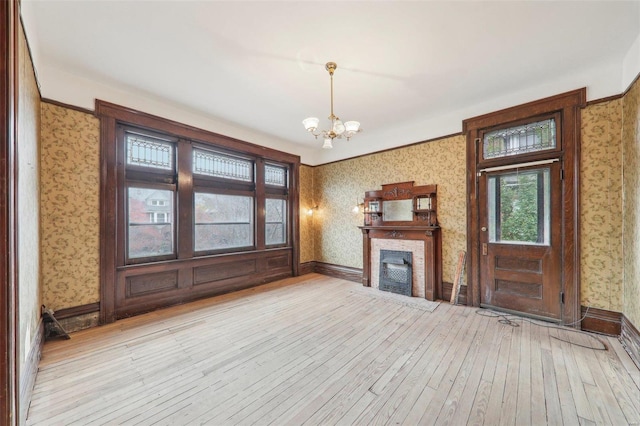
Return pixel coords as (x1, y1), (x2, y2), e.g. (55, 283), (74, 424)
(622, 78), (640, 329)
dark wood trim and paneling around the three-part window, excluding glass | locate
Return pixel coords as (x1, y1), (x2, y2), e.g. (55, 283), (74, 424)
(95, 100), (300, 323)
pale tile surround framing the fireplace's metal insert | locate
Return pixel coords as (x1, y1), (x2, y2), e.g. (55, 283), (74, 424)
(371, 238), (425, 299)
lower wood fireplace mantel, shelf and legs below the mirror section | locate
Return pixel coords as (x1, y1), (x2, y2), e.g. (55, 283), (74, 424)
(359, 225), (442, 300)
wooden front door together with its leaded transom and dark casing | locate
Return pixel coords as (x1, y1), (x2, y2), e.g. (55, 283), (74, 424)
(463, 89), (586, 327)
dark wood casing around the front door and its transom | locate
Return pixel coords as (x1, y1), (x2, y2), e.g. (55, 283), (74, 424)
(463, 88), (586, 324)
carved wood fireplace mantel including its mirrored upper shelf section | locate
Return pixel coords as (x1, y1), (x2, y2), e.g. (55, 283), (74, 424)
(359, 182), (442, 300)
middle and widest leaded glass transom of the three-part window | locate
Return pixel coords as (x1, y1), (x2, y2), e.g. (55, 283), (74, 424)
(193, 149), (253, 182)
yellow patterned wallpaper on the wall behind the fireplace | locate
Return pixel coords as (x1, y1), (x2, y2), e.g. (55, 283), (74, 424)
(313, 136), (467, 282)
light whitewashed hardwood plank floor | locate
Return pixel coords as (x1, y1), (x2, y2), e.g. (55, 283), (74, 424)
(27, 274), (640, 425)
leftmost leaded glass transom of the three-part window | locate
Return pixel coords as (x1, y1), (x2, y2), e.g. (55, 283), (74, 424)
(127, 133), (173, 170)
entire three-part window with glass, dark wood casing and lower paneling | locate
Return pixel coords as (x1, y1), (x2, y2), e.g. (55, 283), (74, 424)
(96, 100), (300, 323)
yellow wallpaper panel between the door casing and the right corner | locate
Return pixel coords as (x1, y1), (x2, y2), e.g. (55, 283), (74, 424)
(580, 99), (622, 312)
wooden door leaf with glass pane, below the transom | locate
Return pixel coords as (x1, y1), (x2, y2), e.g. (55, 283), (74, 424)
(478, 160), (562, 321)
